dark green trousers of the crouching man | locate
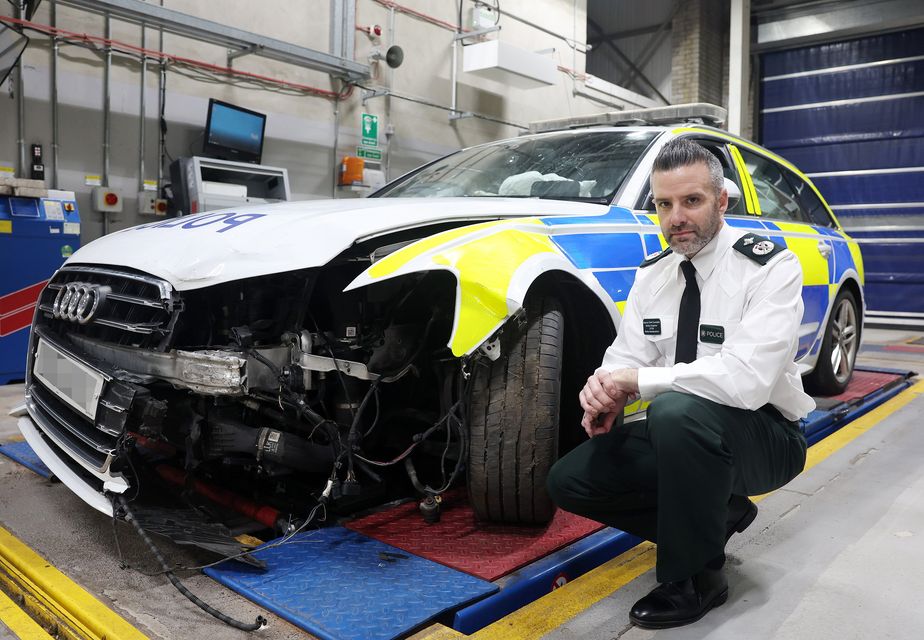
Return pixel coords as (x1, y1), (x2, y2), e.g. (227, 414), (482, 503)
(548, 391), (806, 582)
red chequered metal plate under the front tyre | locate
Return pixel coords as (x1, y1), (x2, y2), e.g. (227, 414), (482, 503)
(345, 491), (603, 581)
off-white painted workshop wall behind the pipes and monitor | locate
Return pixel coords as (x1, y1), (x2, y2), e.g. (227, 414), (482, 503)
(0, 0), (644, 242)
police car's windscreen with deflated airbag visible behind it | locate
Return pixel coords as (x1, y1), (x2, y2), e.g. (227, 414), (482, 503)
(375, 130), (657, 203)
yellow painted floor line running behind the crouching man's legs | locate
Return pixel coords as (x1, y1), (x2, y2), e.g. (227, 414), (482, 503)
(414, 381), (924, 640)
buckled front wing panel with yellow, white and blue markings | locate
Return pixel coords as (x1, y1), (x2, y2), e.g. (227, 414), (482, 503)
(349, 207), (664, 356)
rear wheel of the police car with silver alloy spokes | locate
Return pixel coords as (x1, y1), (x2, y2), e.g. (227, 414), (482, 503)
(804, 289), (860, 396)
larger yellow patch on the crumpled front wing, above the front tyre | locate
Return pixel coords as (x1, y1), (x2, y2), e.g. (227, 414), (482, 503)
(433, 229), (558, 356)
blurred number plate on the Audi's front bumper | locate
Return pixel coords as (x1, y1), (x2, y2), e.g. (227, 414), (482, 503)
(32, 338), (104, 420)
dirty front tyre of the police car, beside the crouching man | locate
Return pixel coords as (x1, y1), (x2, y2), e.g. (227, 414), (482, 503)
(468, 297), (564, 524)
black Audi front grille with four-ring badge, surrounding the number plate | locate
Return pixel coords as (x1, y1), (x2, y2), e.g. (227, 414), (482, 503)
(26, 265), (183, 473)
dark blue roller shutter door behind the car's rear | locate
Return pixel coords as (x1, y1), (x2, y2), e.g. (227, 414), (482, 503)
(760, 29), (924, 322)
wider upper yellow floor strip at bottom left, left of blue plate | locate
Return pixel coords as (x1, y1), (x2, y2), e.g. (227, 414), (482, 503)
(0, 527), (147, 640)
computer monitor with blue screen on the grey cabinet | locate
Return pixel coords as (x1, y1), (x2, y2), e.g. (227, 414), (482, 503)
(202, 98), (266, 163)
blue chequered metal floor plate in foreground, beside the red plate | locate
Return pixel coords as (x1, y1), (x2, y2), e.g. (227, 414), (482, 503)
(205, 527), (498, 640)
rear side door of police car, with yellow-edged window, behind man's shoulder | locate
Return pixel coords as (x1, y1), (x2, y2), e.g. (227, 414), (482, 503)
(729, 144), (836, 359)
